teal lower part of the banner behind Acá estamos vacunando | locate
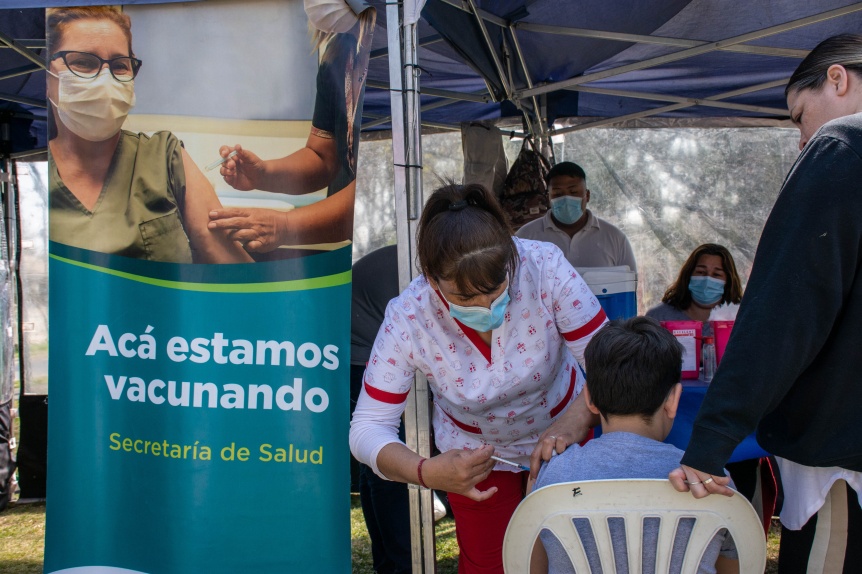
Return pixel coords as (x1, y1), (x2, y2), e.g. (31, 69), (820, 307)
(45, 243), (350, 574)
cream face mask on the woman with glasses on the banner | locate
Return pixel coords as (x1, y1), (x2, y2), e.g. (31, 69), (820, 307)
(48, 69), (135, 142)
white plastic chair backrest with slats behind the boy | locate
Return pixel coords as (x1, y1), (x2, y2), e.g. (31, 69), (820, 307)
(503, 479), (766, 574)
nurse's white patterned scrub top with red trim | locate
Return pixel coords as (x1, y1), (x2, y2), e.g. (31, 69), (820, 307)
(350, 238), (607, 476)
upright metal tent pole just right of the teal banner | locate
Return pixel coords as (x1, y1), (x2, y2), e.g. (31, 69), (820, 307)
(386, 2), (436, 574)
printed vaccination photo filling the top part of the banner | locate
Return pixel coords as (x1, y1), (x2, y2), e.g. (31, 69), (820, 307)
(47, 0), (375, 263)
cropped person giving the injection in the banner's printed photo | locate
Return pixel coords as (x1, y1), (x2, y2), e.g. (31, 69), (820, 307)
(209, 0), (375, 252)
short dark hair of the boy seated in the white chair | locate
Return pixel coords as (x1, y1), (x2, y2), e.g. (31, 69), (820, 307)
(584, 317), (683, 422)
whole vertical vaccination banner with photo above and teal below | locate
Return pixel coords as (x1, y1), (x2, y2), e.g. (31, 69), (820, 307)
(45, 0), (375, 574)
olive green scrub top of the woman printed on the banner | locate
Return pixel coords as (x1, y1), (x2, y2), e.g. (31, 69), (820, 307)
(49, 131), (192, 263)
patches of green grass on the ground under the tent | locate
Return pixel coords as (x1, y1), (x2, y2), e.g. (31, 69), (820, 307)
(0, 494), (780, 574)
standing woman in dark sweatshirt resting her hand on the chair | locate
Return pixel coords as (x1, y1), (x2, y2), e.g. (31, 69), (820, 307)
(671, 34), (862, 574)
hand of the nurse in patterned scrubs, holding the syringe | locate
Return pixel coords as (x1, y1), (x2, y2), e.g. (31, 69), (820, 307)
(422, 445), (497, 502)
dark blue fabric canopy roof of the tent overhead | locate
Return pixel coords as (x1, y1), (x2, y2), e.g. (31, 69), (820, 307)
(5, 0), (862, 153)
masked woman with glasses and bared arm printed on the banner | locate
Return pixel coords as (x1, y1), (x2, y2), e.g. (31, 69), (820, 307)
(47, 7), (251, 263)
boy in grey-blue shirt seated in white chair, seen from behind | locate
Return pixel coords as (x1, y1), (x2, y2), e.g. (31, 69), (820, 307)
(531, 317), (739, 574)
